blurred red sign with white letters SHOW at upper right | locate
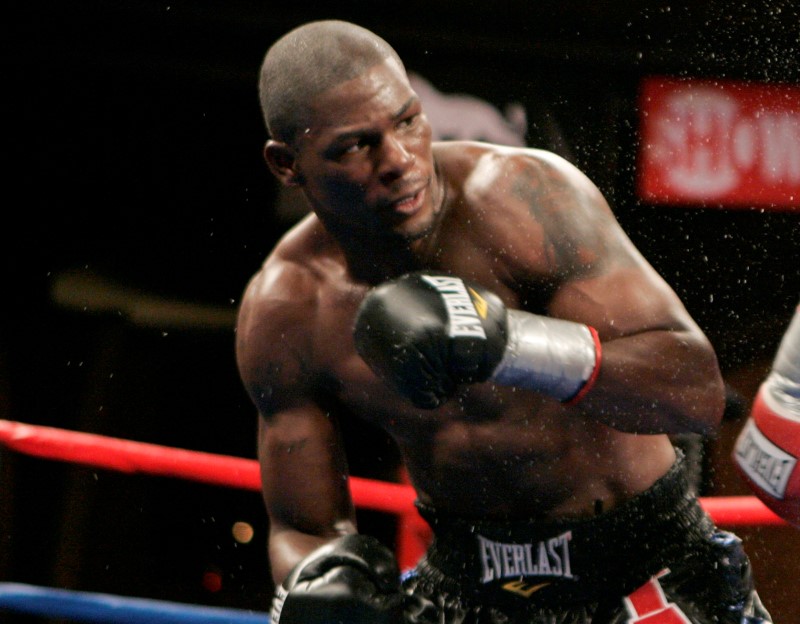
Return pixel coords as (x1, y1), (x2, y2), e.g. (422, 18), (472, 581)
(637, 77), (800, 211)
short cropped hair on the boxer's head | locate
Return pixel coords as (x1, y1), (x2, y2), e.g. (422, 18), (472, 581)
(258, 20), (403, 143)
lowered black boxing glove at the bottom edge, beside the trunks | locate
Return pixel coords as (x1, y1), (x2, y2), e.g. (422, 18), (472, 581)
(270, 534), (403, 624)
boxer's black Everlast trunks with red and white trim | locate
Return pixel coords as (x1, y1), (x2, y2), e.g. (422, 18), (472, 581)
(403, 452), (772, 624)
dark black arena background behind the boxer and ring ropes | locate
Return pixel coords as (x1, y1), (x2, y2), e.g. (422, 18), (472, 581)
(0, 0), (800, 622)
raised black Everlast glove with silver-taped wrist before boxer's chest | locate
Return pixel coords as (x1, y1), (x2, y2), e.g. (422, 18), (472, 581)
(353, 272), (600, 409)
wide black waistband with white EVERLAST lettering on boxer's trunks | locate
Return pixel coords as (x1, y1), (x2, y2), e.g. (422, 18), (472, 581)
(417, 453), (714, 606)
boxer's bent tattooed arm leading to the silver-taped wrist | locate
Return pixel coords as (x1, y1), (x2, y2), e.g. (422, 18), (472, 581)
(520, 157), (724, 433)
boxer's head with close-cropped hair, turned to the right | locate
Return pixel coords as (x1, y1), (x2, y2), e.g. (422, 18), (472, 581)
(259, 20), (441, 240)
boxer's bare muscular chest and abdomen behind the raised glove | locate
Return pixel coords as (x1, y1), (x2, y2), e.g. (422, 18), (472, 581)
(242, 141), (674, 518)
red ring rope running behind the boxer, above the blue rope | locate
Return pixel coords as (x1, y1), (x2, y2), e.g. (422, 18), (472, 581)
(0, 420), (787, 569)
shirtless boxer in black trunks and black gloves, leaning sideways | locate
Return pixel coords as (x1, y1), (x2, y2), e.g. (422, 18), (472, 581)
(237, 21), (770, 624)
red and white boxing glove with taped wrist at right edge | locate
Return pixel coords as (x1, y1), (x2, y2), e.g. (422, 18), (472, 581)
(733, 307), (800, 527)
